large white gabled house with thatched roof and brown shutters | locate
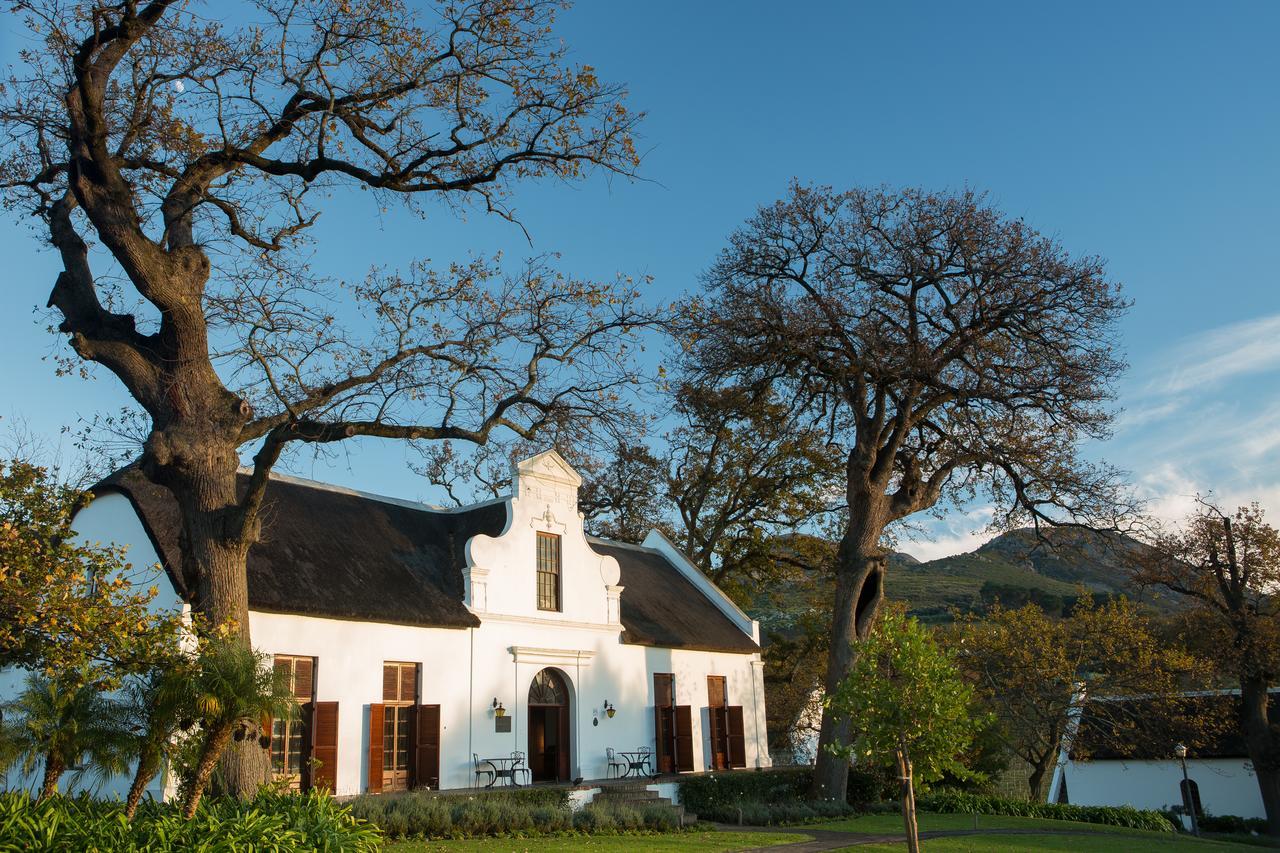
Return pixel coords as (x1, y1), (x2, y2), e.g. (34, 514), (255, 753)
(4, 451), (769, 794)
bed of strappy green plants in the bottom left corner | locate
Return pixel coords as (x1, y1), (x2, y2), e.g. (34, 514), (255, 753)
(0, 793), (383, 853)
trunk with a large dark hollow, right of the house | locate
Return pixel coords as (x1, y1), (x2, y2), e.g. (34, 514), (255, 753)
(810, 491), (887, 802)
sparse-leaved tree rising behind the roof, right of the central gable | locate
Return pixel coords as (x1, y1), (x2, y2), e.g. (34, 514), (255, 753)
(582, 382), (842, 596)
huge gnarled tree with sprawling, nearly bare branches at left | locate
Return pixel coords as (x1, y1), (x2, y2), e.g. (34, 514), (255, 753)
(0, 0), (649, 794)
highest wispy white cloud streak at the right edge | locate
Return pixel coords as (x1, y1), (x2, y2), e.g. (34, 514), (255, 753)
(1148, 314), (1280, 394)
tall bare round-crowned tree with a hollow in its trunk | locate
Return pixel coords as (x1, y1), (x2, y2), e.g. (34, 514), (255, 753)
(686, 186), (1126, 798)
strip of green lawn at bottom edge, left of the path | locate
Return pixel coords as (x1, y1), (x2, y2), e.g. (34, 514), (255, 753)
(387, 833), (810, 853)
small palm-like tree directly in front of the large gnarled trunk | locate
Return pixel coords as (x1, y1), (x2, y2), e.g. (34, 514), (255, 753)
(182, 637), (297, 817)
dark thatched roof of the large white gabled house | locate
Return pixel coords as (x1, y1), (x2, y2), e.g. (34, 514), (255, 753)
(93, 467), (759, 653)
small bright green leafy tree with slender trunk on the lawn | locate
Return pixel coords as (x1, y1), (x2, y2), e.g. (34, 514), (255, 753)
(826, 611), (984, 853)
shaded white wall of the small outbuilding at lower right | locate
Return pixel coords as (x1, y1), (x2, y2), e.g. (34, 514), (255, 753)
(1062, 758), (1266, 817)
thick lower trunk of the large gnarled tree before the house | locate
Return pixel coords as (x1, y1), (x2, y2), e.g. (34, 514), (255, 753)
(148, 438), (270, 798)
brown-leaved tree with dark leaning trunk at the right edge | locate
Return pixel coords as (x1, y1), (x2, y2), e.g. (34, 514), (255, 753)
(1134, 498), (1280, 836)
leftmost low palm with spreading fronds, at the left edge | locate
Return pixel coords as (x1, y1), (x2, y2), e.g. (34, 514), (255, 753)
(4, 672), (132, 800)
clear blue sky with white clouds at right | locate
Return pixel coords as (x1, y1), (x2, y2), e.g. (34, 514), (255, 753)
(0, 0), (1280, 557)
